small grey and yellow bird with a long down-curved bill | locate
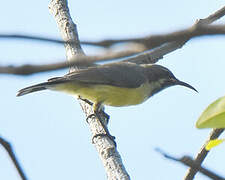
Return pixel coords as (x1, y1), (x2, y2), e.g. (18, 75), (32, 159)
(17, 62), (197, 143)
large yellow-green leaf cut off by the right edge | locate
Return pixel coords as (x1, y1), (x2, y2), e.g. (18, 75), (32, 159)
(196, 96), (225, 128)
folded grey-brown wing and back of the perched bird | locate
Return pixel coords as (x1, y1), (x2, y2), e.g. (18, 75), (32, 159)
(49, 63), (147, 88)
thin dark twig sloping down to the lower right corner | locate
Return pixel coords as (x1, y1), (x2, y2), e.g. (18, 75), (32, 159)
(155, 148), (225, 180)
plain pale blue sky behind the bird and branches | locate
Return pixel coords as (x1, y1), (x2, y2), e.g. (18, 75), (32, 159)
(0, 0), (225, 180)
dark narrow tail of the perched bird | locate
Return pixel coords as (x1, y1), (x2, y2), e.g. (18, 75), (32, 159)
(16, 82), (49, 96)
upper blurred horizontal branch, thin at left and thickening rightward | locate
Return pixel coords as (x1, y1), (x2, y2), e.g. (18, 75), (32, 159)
(0, 24), (225, 49)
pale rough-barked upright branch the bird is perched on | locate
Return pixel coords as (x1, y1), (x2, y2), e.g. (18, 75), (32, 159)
(49, 0), (129, 180)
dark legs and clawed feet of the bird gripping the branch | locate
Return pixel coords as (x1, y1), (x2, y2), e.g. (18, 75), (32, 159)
(86, 103), (116, 146)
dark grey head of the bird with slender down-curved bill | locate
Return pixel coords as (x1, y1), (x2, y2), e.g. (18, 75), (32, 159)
(144, 64), (198, 95)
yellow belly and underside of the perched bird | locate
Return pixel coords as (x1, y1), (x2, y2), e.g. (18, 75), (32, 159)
(52, 83), (151, 106)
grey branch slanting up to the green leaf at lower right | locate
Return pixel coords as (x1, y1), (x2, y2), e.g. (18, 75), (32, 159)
(184, 129), (224, 180)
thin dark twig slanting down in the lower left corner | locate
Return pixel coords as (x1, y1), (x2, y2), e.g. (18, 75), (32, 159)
(0, 137), (27, 180)
